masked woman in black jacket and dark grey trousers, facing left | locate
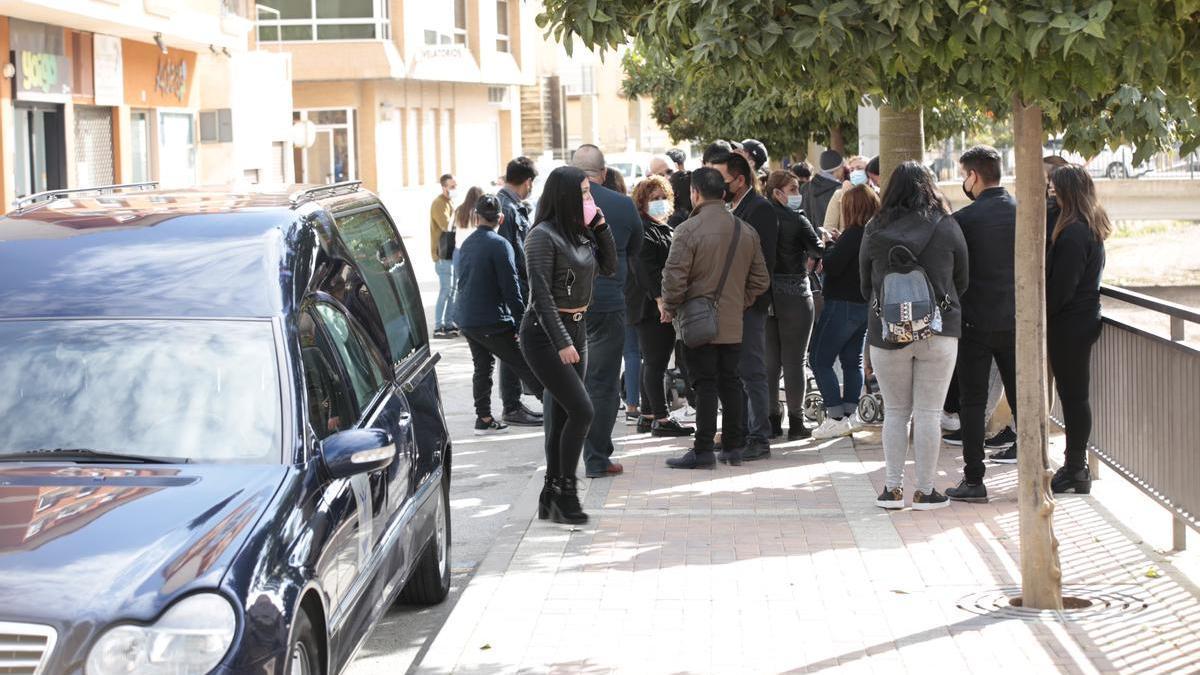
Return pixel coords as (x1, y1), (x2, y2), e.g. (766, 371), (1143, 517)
(763, 171), (824, 441)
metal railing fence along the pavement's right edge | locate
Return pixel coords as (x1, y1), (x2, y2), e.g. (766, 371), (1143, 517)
(1054, 286), (1200, 550)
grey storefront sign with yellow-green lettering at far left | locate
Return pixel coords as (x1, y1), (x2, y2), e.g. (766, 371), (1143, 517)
(8, 19), (71, 103)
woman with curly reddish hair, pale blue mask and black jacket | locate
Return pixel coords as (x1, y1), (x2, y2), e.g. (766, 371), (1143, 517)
(625, 175), (696, 437)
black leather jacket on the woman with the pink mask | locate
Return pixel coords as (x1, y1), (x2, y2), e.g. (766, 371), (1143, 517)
(524, 222), (617, 350)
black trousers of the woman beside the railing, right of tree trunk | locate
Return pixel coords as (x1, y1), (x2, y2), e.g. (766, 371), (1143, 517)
(1046, 316), (1100, 470)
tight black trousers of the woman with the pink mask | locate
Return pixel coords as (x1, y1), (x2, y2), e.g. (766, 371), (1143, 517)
(521, 312), (595, 478)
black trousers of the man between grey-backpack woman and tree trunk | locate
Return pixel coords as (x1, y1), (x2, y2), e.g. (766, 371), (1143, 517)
(956, 325), (1016, 483)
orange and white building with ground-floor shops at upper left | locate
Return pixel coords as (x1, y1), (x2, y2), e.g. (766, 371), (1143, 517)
(0, 0), (293, 207)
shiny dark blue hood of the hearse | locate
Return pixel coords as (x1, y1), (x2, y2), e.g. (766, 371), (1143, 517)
(0, 462), (287, 625)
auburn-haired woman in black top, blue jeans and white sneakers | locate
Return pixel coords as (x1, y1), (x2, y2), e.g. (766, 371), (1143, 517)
(810, 185), (880, 441)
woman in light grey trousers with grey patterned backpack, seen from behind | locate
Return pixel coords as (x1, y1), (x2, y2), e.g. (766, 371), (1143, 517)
(859, 161), (967, 510)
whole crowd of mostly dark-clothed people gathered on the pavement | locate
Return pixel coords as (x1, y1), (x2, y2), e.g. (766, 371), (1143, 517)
(430, 139), (1111, 524)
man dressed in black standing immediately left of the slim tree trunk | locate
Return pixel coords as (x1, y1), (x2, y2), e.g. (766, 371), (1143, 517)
(946, 145), (1016, 503)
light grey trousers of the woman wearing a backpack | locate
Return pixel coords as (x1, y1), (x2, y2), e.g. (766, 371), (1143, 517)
(871, 335), (959, 487)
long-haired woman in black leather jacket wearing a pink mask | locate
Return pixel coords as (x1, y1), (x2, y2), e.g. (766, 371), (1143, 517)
(521, 167), (617, 525)
